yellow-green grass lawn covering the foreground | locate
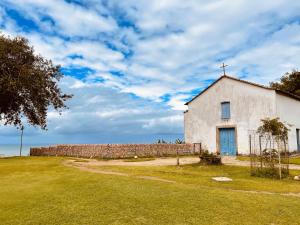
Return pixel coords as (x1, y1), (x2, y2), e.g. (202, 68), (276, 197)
(0, 157), (300, 225)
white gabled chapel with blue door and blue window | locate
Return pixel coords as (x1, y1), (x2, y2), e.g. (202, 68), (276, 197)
(184, 75), (300, 155)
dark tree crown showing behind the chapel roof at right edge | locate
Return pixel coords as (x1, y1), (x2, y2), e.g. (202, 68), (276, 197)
(270, 70), (300, 97)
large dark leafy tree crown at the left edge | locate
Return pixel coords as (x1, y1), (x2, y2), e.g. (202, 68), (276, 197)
(0, 34), (72, 129)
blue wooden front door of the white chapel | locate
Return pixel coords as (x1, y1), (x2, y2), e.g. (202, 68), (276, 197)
(219, 128), (236, 155)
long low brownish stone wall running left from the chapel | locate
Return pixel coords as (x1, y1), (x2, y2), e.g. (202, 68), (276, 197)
(30, 144), (195, 159)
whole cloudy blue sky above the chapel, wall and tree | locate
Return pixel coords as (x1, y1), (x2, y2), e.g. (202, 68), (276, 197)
(0, 0), (300, 144)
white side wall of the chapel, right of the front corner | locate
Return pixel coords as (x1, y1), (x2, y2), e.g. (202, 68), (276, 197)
(276, 94), (300, 151)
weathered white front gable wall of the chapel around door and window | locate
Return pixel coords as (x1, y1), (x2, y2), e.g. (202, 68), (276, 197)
(184, 77), (276, 154)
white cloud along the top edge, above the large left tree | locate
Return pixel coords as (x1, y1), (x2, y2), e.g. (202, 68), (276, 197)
(5, 0), (117, 37)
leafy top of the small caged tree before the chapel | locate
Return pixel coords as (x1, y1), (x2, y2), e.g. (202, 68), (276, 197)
(257, 117), (290, 140)
